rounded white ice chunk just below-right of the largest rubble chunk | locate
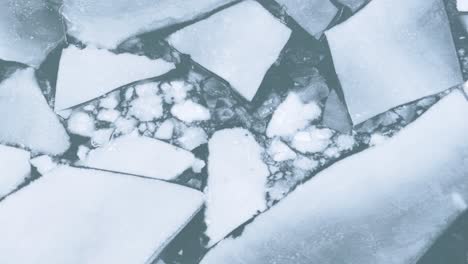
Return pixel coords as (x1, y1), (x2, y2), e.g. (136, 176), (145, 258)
(291, 127), (333, 153)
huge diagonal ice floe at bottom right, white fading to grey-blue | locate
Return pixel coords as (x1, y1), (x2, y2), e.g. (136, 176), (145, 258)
(201, 91), (468, 264)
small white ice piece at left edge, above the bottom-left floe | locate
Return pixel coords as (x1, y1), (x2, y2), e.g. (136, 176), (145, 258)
(0, 145), (31, 199)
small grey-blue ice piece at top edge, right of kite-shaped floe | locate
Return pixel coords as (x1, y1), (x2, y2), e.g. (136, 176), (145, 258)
(276, 0), (338, 37)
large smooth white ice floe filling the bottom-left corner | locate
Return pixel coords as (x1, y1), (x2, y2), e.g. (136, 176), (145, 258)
(0, 166), (203, 264)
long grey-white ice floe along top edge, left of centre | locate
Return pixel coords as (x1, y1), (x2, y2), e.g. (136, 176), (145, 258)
(62, 0), (235, 49)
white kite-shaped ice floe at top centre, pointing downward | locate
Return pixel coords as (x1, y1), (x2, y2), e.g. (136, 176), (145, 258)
(168, 0), (291, 101)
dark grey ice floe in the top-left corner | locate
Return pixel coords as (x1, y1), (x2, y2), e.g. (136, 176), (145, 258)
(0, 0), (65, 68)
